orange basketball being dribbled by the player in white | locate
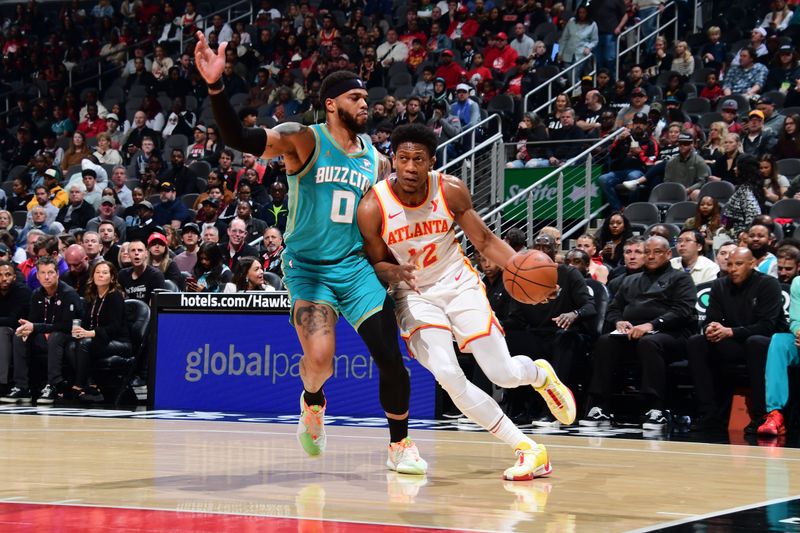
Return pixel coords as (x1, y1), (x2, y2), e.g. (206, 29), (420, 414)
(503, 250), (558, 304)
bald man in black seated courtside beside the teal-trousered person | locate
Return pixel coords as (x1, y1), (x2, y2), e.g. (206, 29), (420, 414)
(688, 248), (787, 433)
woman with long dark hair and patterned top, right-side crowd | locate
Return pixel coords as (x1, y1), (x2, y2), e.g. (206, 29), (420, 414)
(722, 154), (765, 235)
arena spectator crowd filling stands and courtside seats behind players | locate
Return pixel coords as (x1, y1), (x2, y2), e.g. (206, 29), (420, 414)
(0, 0), (800, 435)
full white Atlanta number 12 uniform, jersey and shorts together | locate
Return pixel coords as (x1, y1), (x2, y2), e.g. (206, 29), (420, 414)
(373, 172), (502, 355)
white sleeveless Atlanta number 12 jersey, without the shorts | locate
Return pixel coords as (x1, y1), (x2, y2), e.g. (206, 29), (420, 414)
(374, 172), (464, 287)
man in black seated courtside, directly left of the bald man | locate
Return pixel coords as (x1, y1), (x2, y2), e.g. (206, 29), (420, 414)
(579, 237), (697, 430)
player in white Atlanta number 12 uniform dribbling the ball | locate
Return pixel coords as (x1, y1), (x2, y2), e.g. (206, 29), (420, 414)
(358, 124), (576, 481)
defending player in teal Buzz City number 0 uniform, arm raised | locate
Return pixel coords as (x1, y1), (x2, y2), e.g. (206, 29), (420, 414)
(195, 32), (427, 474)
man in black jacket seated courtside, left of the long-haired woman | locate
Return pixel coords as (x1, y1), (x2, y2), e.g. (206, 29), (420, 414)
(2, 256), (82, 404)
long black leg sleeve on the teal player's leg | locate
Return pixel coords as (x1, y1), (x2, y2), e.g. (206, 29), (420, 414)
(358, 296), (411, 415)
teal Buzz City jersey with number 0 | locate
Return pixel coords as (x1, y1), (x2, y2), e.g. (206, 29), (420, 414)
(284, 124), (378, 263)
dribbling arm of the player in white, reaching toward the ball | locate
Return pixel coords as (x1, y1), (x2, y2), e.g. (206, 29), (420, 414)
(442, 175), (514, 266)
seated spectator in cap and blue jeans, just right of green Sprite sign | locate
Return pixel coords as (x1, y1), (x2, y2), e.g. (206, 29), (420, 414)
(598, 113), (658, 211)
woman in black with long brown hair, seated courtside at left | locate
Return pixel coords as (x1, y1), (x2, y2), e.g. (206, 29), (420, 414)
(72, 261), (133, 402)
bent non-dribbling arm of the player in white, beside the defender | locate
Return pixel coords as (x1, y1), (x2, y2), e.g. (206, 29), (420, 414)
(357, 191), (417, 290)
